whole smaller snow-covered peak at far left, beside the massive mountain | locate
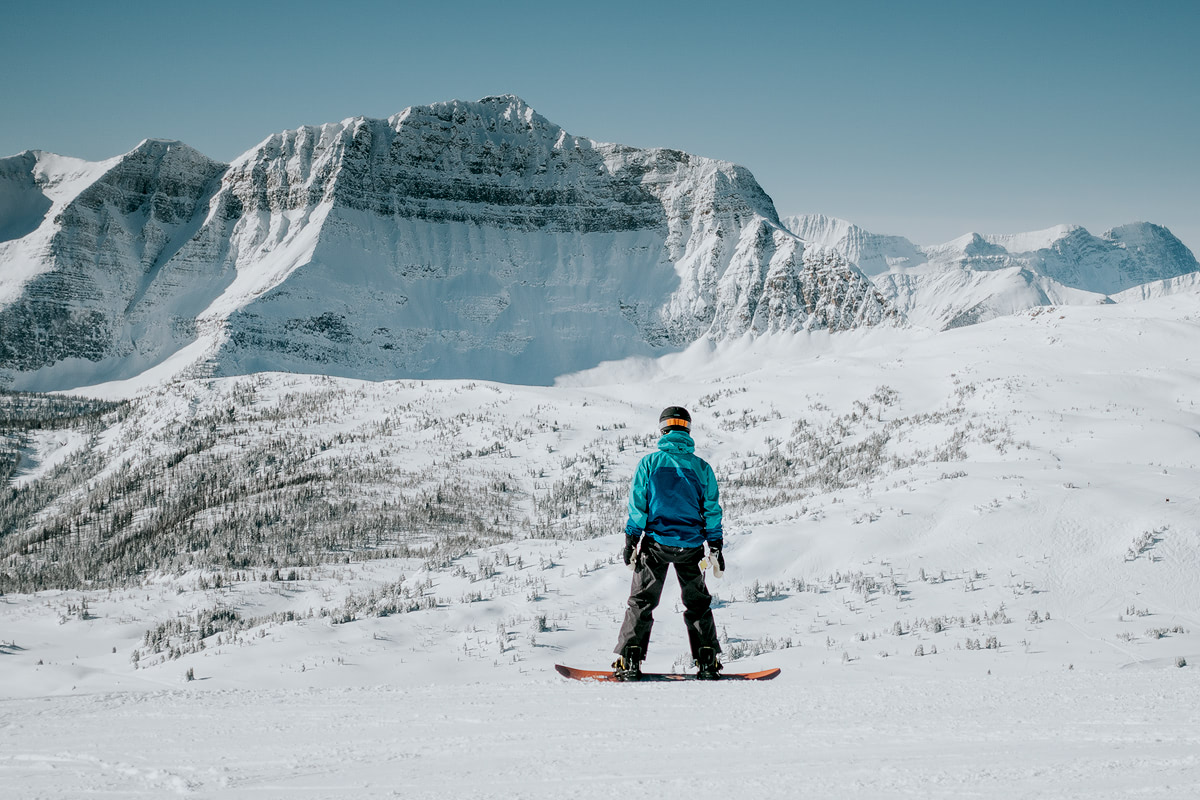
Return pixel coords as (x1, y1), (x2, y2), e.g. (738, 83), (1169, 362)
(0, 140), (224, 375)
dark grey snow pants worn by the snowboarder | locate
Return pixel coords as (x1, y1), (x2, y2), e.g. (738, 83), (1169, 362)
(613, 536), (721, 658)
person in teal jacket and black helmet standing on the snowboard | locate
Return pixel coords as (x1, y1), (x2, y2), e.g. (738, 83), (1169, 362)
(613, 405), (725, 680)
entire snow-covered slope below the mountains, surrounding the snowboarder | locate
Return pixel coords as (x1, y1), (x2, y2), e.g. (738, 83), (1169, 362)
(0, 291), (1200, 798)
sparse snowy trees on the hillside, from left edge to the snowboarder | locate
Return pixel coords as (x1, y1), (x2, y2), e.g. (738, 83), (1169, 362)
(0, 377), (628, 591)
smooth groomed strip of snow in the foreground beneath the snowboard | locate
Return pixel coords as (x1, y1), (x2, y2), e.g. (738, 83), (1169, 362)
(0, 669), (1200, 800)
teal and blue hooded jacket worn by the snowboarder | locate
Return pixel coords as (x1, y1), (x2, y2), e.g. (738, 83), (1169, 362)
(625, 431), (722, 547)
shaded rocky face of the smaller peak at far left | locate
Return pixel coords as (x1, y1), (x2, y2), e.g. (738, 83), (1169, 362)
(0, 140), (224, 372)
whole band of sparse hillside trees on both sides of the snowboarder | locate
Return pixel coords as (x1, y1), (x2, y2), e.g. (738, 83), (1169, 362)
(0, 375), (1022, 599)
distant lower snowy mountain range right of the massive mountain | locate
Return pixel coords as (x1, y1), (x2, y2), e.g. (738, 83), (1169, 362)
(782, 215), (1200, 330)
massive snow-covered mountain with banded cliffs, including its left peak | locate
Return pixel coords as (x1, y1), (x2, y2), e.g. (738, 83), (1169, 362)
(0, 96), (895, 389)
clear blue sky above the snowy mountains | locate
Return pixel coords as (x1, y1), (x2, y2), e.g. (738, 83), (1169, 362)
(0, 0), (1200, 252)
